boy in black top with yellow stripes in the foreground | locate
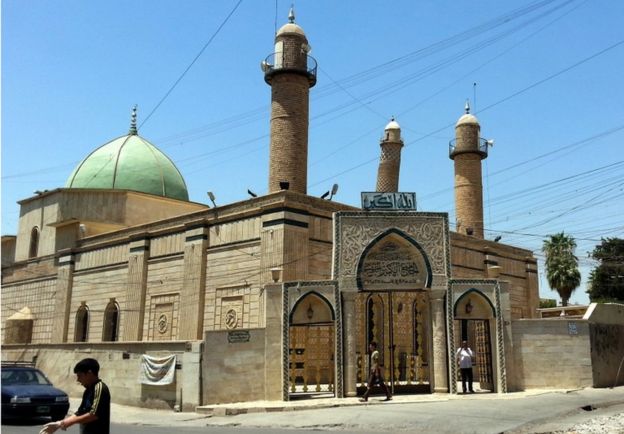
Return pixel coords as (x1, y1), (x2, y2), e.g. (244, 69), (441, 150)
(60, 359), (110, 434)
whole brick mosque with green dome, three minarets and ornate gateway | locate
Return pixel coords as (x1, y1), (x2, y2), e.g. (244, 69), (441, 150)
(2, 12), (622, 409)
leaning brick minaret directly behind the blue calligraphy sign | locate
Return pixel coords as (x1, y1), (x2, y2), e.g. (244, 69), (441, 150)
(377, 118), (403, 192)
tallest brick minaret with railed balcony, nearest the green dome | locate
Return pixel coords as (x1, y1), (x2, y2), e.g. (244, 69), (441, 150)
(262, 9), (316, 194)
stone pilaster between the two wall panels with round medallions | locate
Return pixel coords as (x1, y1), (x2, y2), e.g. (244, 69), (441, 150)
(178, 222), (209, 340)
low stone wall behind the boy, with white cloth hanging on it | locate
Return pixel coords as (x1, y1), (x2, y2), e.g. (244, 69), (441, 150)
(2, 341), (202, 411)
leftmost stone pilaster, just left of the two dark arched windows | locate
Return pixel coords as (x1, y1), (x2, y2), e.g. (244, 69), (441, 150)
(50, 250), (75, 344)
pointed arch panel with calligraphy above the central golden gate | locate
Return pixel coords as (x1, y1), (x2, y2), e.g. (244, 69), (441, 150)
(357, 228), (432, 291)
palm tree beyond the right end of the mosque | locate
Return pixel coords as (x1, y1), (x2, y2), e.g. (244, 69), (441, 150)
(542, 232), (581, 306)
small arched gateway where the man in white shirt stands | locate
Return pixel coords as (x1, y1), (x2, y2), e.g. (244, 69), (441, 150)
(454, 289), (496, 392)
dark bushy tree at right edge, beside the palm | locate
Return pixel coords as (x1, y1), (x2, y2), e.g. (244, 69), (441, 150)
(587, 238), (624, 302)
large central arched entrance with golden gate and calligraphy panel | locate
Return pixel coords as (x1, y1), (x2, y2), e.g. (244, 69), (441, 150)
(355, 229), (431, 393)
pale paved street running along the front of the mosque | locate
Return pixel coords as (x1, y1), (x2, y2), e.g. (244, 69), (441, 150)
(2, 387), (624, 434)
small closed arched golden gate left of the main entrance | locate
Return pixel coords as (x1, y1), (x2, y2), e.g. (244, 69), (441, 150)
(288, 292), (335, 399)
